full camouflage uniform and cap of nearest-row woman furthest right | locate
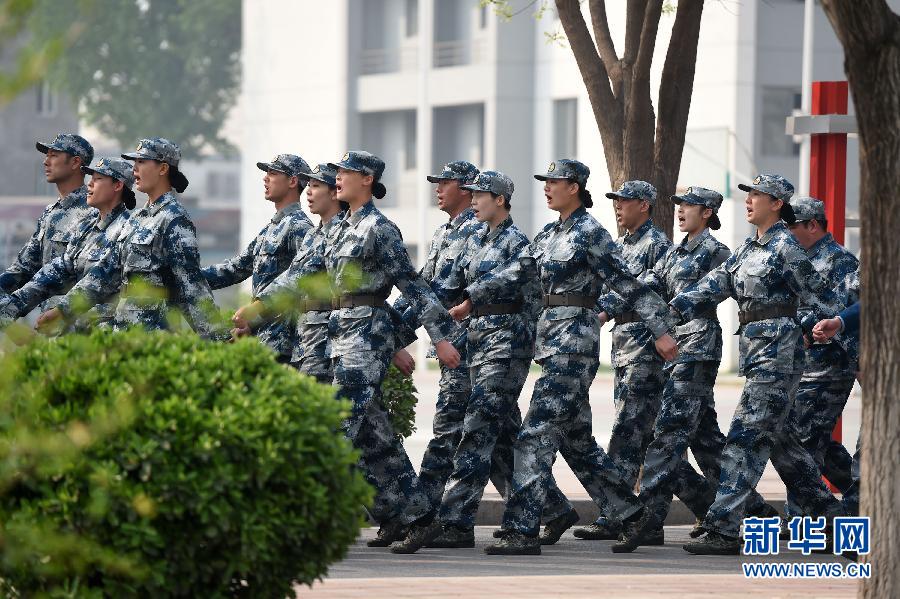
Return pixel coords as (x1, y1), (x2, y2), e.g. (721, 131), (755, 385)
(670, 175), (843, 539)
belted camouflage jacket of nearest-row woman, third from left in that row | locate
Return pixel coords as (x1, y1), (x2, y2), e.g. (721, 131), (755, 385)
(466, 207), (669, 360)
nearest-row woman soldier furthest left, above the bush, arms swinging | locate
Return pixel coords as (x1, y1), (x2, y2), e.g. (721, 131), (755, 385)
(37, 138), (230, 340)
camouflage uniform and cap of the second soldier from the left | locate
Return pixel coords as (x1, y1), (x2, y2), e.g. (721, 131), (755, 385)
(0, 158), (135, 331)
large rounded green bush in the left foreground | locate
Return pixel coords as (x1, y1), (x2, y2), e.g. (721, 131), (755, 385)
(0, 330), (372, 598)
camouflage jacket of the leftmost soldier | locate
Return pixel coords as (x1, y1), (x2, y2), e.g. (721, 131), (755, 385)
(0, 185), (97, 310)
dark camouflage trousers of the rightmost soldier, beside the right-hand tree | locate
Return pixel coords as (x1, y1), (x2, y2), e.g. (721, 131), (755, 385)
(785, 378), (854, 517)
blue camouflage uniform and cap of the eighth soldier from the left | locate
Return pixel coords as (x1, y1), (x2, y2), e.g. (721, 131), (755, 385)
(432, 171), (540, 529)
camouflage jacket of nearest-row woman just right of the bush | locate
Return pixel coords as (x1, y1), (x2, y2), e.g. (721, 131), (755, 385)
(259, 201), (462, 357)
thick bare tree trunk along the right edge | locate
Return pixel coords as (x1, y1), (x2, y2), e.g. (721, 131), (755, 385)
(822, 0), (900, 598)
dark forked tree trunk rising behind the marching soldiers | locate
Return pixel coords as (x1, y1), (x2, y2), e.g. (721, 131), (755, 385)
(556, 0), (703, 238)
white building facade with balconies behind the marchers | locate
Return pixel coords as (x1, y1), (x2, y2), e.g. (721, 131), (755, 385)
(239, 0), (880, 370)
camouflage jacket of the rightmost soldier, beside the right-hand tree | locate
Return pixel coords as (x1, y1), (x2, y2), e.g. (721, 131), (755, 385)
(800, 233), (859, 381)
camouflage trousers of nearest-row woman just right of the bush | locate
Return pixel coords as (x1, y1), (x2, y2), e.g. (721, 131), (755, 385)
(334, 352), (431, 524)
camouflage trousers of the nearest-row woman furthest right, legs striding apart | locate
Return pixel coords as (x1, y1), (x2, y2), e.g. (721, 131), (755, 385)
(703, 369), (844, 537)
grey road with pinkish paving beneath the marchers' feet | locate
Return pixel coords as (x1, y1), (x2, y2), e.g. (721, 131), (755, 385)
(301, 526), (856, 598)
